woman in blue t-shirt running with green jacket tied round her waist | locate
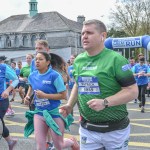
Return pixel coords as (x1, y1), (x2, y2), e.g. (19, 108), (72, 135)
(25, 52), (79, 150)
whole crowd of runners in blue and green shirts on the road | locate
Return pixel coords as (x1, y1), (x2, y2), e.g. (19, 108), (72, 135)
(0, 20), (150, 150)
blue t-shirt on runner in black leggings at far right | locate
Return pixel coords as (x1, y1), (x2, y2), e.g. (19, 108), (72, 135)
(132, 63), (150, 85)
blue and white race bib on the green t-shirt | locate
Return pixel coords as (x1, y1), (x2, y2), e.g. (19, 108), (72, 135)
(78, 77), (100, 95)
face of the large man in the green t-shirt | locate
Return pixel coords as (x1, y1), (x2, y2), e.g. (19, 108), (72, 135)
(81, 24), (103, 51)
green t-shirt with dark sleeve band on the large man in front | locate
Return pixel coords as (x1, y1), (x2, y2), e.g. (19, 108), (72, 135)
(73, 48), (135, 123)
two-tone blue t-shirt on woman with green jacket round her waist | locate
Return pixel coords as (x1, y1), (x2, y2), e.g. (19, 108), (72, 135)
(28, 68), (66, 110)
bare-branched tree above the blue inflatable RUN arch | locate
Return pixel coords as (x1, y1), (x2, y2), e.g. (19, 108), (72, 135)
(110, 0), (150, 36)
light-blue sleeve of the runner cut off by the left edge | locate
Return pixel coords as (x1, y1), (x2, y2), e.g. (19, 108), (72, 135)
(5, 66), (19, 88)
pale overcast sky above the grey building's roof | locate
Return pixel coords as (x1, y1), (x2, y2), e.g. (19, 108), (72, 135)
(0, 0), (116, 25)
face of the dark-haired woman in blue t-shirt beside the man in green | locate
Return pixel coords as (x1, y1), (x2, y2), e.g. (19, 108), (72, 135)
(35, 53), (50, 72)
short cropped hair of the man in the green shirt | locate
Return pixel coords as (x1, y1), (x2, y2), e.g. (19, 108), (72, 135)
(83, 19), (107, 32)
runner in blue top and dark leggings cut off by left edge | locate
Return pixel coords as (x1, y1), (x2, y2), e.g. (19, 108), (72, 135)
(0, 56), (19, 150)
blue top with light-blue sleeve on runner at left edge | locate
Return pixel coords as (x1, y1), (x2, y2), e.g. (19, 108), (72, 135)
(0, 64), (19, 100)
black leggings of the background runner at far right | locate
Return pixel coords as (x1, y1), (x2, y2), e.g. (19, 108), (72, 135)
(138, 84), (147, 106)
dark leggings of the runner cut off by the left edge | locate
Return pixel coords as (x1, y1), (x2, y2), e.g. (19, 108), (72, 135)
(0, 99), (9, 138)
